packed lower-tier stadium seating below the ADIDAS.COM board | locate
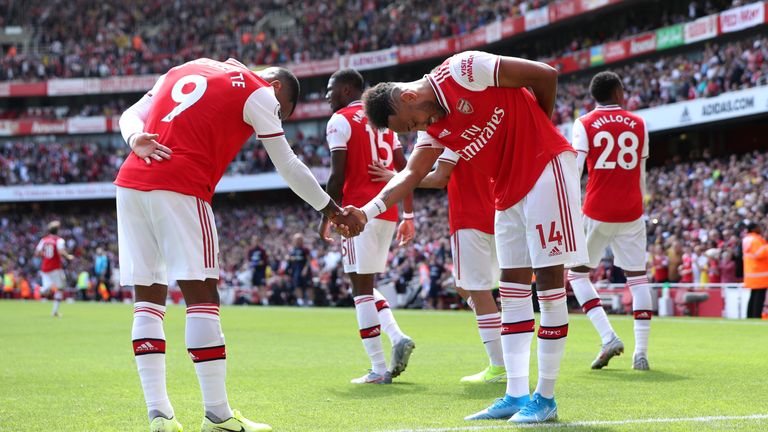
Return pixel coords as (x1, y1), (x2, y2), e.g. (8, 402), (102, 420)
(0, 152), (768, 306)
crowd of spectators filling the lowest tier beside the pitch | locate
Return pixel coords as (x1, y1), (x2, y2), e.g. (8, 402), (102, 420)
(0, 152), (768, 305)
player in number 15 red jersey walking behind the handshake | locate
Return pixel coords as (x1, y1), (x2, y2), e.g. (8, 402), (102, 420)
(320, 69), (415, 384)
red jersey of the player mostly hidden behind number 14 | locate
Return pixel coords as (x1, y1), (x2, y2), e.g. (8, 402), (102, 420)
(436, 148), (496, 234)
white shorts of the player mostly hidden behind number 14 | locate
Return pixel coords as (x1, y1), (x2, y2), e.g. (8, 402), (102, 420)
(451, 229), (500, 291)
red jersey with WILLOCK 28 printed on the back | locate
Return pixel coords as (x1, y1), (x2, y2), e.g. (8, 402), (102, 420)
(572, 105), (648, 222)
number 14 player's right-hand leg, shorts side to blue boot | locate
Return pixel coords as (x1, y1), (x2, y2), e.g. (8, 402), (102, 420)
(510, 152), (589, 423)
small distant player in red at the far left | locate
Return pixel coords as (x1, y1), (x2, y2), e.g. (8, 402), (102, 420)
(35, 221), (74, 317)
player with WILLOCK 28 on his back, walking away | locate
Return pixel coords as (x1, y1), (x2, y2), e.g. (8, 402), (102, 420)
(568, 71), (653, 370)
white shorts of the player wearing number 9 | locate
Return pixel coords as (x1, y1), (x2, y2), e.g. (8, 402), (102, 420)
(117, 187), (219, 286)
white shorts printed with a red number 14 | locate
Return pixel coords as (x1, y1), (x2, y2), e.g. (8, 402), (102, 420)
(495, 152), (588, 269)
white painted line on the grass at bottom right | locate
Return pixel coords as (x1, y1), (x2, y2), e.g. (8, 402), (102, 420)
(382, 414), (768, 432)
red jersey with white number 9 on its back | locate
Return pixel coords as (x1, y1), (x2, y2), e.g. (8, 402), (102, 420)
(115, 58), (283, 202)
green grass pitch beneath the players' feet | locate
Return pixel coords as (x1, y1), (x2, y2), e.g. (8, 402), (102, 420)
(0, 301), (768, 432)
